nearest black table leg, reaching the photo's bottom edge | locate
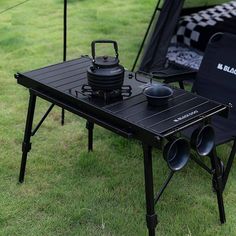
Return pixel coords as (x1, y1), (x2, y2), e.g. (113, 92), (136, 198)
(143, 144), (158, 236)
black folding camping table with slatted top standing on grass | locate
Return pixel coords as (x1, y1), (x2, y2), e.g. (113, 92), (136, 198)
(15, 56), (226, 236)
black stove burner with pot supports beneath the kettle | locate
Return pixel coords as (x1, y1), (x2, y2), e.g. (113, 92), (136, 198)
(81, 84), (132, 103)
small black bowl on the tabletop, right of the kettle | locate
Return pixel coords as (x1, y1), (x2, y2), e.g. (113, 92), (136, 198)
(143, 85), (173, 106)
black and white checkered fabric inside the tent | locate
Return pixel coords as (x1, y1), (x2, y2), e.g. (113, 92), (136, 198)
(171, 1), (236, 51)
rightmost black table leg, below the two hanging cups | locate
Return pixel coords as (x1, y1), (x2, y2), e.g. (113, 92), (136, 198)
(210, 148), (226, 224)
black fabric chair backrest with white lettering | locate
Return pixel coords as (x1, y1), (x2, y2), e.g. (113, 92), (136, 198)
(193, 33), (236, 128)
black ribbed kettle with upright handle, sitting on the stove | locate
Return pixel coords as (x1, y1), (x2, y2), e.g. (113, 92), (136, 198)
(87, 40), (125, 91)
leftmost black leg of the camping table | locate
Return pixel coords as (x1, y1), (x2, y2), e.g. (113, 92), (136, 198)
(19, 92), (36, 183)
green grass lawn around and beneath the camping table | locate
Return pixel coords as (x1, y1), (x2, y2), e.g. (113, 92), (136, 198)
(0, 0), (236, 236)
